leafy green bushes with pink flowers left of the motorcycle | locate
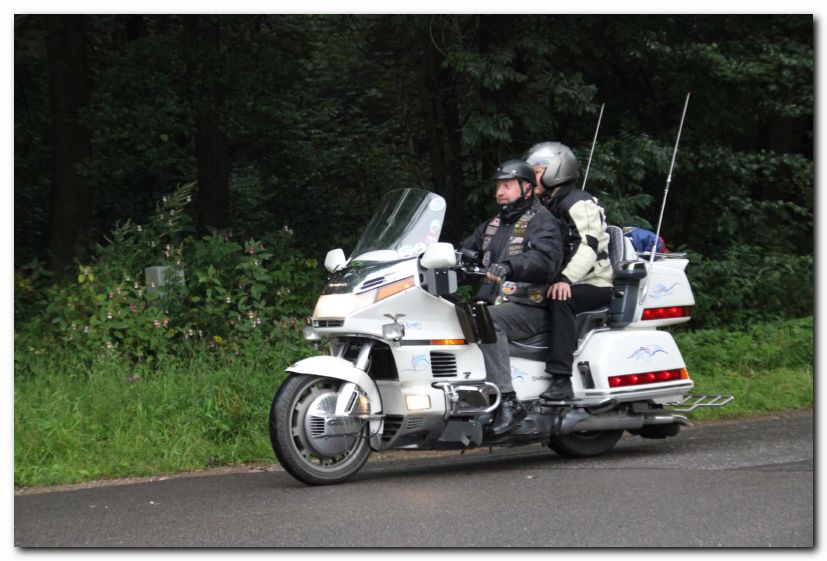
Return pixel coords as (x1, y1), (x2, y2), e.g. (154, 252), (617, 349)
(15, 186), (324, 368)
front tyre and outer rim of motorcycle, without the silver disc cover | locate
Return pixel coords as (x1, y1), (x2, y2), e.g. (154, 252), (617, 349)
(269, 374), (370, 485)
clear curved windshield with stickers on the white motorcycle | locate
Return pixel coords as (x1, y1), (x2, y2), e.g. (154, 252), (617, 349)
(350, 189), (445, 265)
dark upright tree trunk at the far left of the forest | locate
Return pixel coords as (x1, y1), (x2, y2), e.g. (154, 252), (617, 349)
(46, 15), (91, 270)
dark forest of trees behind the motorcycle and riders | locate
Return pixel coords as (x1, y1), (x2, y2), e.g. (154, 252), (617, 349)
(14, 14), (814, 332)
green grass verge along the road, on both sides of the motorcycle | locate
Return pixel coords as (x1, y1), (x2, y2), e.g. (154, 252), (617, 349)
(14, 317), (813, 486)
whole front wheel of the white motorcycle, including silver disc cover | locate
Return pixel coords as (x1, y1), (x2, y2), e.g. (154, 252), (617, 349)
(270, 374), (370, 485)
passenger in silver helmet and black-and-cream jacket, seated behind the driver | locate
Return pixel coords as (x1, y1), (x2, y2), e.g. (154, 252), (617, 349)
(526, 142), (612, 401)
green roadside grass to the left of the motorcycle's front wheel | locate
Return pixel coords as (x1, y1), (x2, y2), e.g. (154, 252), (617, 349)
(14, 348), (294, 485)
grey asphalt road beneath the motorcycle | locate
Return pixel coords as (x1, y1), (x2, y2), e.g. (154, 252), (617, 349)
(14, 414), (814, 548)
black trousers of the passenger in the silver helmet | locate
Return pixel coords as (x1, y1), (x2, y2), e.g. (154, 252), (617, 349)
(546, 284), (612, 376)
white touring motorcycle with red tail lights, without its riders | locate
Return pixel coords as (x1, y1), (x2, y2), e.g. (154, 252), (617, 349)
(269, 189), (732, 485)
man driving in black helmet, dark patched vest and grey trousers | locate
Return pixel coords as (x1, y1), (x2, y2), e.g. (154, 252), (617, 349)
(462, 160), (563, 435)
